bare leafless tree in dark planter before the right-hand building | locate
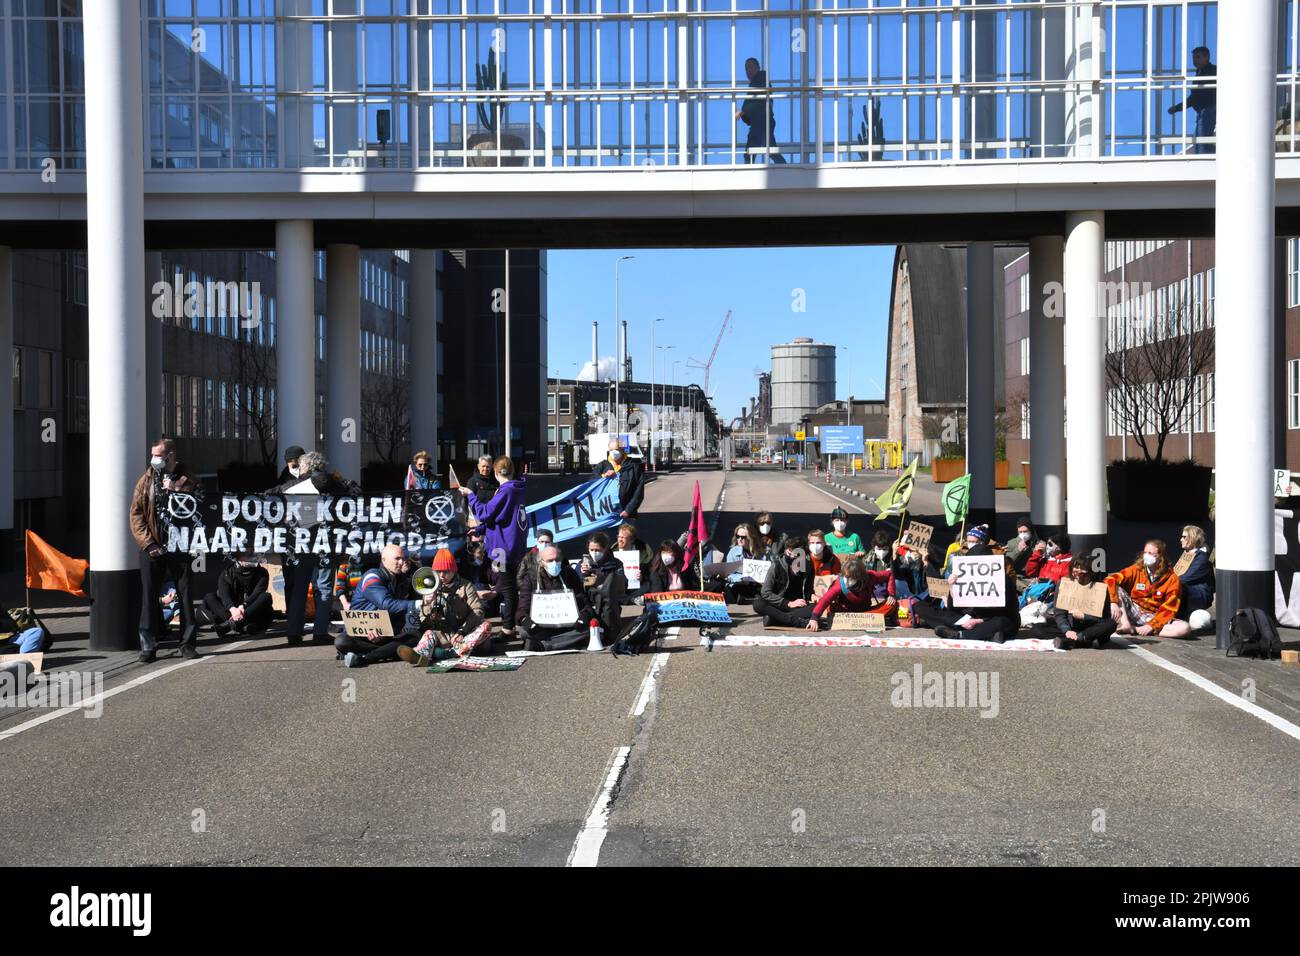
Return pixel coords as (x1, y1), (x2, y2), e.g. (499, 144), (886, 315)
(1106, 303), (1214, 462)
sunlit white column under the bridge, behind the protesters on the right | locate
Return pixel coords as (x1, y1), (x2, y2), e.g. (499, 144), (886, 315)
(1066, 212), (1106, 554)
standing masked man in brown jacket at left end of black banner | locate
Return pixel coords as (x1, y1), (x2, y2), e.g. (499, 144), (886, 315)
(130, 438), (200, 663)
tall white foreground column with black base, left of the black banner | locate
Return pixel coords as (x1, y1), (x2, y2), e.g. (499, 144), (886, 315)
(83, 0), (148, 650)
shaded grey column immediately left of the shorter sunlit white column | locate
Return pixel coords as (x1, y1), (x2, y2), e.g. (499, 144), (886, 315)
(1030, 235), (1065, 533)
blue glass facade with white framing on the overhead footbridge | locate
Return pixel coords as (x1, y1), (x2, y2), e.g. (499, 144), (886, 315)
(10, 0), (1300, 170)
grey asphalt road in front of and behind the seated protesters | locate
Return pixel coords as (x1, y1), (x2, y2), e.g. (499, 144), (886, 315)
(0, 471), (1300, 865)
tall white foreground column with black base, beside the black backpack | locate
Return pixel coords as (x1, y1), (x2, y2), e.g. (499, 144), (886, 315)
(1214, 0), (1278, 648)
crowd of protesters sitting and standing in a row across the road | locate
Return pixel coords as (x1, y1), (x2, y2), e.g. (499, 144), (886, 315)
(131, 438), (1214, 667)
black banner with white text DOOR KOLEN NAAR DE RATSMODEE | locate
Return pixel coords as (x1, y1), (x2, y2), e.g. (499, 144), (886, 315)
(157, 490), (465, 557)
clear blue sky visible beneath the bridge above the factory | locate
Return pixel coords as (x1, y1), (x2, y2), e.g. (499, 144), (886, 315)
(547, 246), (894, 421)
